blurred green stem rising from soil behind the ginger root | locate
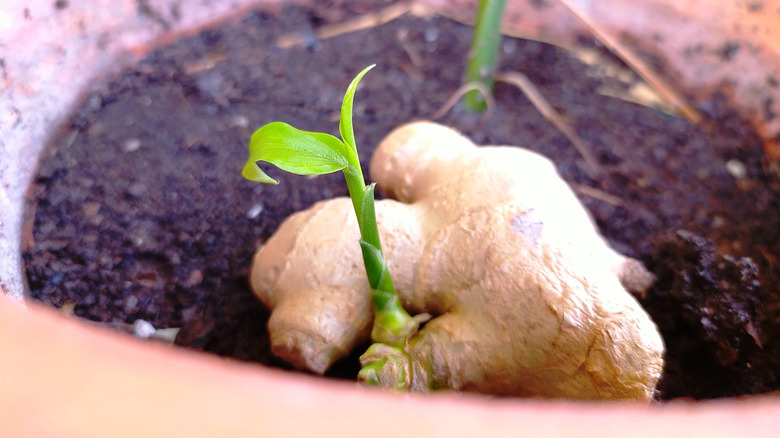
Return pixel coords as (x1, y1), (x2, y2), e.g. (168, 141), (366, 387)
(464, 0), (506, 111)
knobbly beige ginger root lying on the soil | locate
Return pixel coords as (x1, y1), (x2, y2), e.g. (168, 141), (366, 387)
(250, 122), (663, 400)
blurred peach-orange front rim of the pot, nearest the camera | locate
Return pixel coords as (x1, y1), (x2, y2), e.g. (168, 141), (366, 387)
(0, 297), (780, 437)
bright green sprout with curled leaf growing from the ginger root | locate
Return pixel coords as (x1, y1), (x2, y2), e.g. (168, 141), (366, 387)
(242, 64), (419, 387)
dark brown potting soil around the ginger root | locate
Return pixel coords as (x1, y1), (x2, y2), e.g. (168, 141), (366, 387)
(23, 1), (780, 399)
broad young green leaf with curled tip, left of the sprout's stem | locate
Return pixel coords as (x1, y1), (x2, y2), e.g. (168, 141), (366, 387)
(242, 122), (348, 184)
